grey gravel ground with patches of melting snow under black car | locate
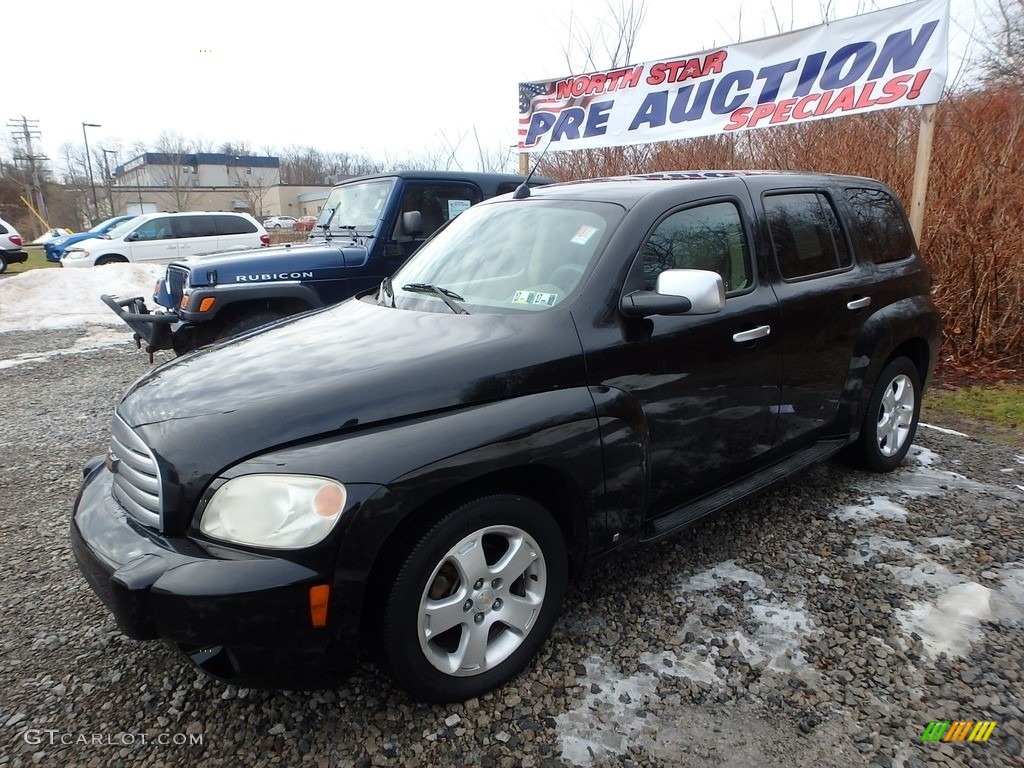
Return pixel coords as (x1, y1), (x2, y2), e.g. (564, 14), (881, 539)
(0, 331), (1024, 767)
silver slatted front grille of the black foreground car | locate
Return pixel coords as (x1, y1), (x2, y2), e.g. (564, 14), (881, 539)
(106, 415), (162, 528)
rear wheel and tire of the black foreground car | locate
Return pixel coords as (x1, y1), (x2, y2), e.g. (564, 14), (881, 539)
(856, 357), (921, 472)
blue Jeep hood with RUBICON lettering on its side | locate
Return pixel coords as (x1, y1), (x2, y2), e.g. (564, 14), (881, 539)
(175, 239), (368, 287)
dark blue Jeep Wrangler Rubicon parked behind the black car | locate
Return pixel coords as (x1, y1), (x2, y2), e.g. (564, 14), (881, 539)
(102, 171), (551, 359)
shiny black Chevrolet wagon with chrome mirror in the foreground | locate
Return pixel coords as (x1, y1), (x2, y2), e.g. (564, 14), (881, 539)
(71, 172), (940, 701)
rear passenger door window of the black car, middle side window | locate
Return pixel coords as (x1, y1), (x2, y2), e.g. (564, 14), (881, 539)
(764, 191), (853, 280)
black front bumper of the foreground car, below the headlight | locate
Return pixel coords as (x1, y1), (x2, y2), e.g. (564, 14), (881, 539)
(71, 465), (357, 688)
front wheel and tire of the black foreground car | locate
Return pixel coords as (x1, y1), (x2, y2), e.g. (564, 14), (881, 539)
(381, 495), (568, 703)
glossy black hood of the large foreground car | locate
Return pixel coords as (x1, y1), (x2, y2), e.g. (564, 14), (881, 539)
(118, 300), (585, 484)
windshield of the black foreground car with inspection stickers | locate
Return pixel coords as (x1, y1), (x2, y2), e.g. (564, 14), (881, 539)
(387, 199), (624, 312)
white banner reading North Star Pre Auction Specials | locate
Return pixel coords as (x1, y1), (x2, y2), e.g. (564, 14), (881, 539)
(518, 0), (949, 152)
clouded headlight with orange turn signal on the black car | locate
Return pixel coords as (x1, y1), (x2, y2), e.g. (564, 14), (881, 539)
(200, 475), (346, 549)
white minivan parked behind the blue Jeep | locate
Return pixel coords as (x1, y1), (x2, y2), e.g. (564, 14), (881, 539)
(60, 211), (270, 267)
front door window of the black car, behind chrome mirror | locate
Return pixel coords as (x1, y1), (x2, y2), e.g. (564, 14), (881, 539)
(641, 202), (754, 294)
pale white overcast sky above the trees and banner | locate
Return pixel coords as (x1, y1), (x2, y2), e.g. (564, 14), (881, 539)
(6, 0), (984, 170)
